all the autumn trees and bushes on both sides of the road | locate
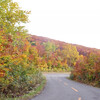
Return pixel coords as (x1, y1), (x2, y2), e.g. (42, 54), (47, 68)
(0, 0), (100, 97)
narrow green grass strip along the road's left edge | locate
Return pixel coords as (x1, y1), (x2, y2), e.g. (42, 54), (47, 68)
(0, 77), (46, 100)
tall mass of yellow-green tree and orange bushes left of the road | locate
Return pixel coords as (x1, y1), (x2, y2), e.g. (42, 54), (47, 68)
(0, 0), (43, 97)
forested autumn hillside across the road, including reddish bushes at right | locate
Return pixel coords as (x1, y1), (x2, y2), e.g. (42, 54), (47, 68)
(28, 35), (100, 86)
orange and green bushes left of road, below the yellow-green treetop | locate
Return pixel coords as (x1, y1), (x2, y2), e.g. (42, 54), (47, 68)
(0, 33), (43, 97)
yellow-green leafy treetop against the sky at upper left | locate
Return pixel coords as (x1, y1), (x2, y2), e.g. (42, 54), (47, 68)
(0, 0), (30, 38)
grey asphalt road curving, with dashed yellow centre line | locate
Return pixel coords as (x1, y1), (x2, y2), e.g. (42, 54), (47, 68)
(32, 74), (100, 100)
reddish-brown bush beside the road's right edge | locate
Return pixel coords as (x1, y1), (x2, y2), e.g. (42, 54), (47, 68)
(71, 53), (100, 87)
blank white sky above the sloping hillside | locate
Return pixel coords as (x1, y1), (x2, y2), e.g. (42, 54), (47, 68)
(13, 0), (100, 49)
